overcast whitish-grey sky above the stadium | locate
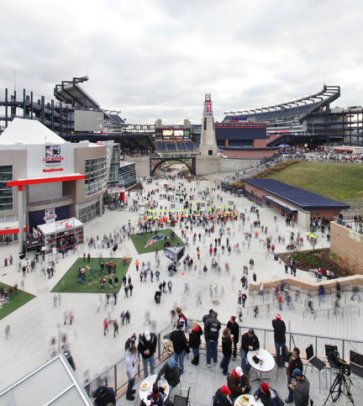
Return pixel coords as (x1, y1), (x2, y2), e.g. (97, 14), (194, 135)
(0, 0), (363, 123)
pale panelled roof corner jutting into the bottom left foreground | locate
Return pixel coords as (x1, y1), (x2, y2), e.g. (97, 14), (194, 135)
(0, 354), (92, 406)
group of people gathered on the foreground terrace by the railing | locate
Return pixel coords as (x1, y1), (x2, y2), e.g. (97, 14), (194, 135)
(107, 306), (310, 406)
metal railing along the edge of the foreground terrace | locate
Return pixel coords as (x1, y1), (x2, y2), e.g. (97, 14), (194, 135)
(84, 321), (363, 397)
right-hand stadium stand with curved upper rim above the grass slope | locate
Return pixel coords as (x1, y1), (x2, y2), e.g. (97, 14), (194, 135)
(223, 85), (363, 147)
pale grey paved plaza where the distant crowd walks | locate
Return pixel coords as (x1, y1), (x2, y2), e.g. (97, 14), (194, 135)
(0, 177), (363, 404)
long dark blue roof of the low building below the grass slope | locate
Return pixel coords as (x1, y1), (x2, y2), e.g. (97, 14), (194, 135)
(243, 178), (350, 210)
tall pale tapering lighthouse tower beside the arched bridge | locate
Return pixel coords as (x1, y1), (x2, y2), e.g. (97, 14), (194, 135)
(199, 94), (217, 157)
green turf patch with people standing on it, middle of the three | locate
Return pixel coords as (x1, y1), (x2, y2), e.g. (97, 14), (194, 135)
(52, 258), (131, 293)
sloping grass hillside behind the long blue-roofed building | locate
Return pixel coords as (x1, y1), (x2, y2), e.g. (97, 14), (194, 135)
(268, 162), (363, 203)
